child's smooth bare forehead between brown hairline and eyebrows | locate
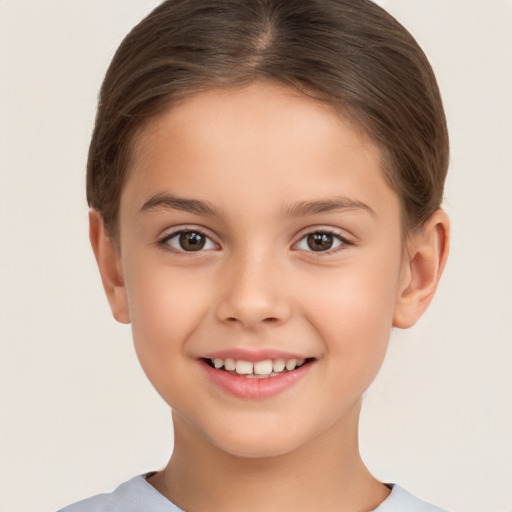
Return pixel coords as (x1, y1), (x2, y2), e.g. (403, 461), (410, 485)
(122, 83), (393, 220)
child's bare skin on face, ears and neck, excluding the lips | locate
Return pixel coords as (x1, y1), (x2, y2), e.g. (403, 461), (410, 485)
(90, 83), (448, 512)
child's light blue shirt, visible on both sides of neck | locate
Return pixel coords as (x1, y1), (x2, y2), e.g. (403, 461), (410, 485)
(59, 475), (452, 512)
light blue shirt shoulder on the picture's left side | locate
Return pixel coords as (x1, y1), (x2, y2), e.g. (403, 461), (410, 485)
(59, 476), (182, 512)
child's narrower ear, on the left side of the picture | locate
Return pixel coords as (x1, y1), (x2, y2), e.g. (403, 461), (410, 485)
(89, 210), (130, 324)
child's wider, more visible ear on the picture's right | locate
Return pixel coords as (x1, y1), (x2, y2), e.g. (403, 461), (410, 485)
(393, 210), (450, 329)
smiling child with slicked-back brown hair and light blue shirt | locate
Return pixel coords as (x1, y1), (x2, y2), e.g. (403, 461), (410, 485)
(59, 0), (449, 512)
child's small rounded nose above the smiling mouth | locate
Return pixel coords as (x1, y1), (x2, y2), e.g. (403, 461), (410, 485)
(212, 250), (292, 329)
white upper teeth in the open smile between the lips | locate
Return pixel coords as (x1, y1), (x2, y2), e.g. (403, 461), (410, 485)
(203, 357), (314, 379)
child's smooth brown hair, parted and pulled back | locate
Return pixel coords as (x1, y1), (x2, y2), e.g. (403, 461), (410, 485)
(87, 0), (448, 237)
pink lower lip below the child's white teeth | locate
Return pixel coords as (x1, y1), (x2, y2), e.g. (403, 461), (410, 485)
(199, 359), (313, 400)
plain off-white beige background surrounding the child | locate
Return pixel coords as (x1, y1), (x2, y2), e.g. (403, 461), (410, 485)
(0, 0), (512, 512)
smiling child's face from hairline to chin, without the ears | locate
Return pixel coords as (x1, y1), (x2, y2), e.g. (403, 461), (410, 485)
(115, 84), (404, 457)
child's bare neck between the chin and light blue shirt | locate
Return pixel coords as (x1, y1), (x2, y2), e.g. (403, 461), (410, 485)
(150, 403), (389, 512)
